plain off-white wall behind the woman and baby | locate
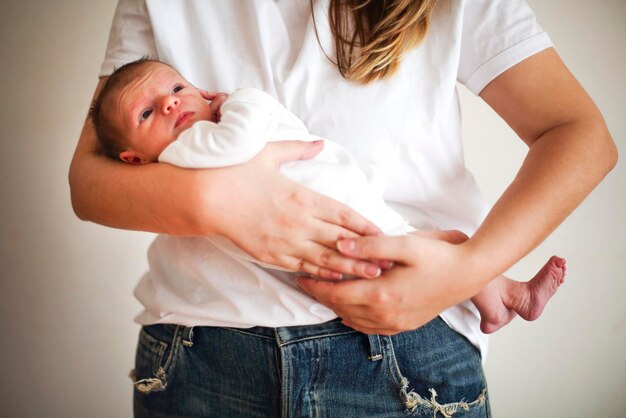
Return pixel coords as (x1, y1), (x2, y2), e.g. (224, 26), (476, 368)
(0, 0), (626, 418)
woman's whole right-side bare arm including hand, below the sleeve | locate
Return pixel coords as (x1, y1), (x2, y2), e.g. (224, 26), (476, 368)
(298, 49), (617, 334)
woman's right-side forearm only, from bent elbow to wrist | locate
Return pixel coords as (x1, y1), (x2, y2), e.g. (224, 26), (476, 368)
(464, 116), (617, 280)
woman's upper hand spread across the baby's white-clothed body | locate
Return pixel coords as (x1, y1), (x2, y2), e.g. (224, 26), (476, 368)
(198, 141), (381, 279)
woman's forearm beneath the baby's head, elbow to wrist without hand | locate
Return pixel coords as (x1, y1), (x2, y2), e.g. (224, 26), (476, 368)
(69, 109), (210, 235)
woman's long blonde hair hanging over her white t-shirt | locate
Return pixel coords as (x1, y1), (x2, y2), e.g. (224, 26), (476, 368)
(311, 0), (437, 84)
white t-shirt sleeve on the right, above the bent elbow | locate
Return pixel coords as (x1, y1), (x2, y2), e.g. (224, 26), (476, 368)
(457, 0), (552, 94)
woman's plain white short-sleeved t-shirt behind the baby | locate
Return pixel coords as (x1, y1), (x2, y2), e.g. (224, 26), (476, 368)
(100, 0), (551, 357)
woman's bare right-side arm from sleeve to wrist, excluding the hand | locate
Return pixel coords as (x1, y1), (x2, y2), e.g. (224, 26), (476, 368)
(464, 50), (617, 280)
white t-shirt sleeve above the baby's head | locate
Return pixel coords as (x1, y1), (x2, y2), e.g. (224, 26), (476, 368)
(100, 0), (158, 77)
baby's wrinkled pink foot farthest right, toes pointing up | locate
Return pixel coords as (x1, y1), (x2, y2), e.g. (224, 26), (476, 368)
(503, 256), (566, 321)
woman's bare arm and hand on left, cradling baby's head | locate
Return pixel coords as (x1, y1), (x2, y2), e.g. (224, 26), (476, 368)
(69, 79), (378, 277)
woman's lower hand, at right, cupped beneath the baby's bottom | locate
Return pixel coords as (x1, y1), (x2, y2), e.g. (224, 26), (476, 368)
(297, 231), (482, 335)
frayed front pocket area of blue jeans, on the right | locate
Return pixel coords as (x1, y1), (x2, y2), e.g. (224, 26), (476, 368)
(381, 319), (490, 418)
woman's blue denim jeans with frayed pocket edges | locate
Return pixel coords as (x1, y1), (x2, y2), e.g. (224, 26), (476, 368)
(133, 318), (491, 418)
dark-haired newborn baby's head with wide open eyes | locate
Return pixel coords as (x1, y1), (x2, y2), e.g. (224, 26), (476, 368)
(89, 58), (222, 164)
